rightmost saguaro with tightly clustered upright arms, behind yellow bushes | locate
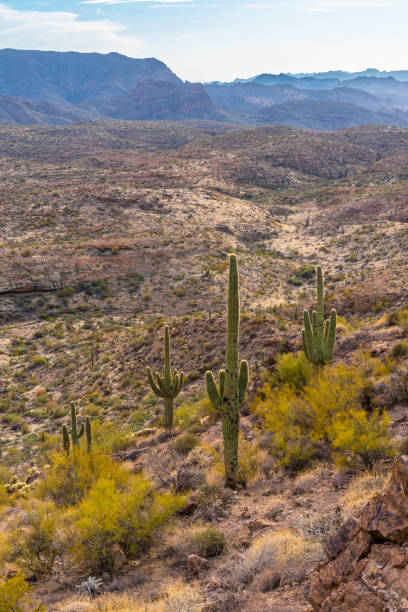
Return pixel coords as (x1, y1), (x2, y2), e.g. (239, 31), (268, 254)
(302, 266), (337, 365)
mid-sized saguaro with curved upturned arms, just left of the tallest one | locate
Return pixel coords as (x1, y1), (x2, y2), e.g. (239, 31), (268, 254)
(147, 325), (184, 430)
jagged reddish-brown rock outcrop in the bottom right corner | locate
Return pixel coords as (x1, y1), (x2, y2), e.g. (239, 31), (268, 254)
(309, 457), (408, 612)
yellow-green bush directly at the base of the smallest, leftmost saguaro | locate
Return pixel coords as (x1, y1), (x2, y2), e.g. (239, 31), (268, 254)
(37, 451), (131, 506)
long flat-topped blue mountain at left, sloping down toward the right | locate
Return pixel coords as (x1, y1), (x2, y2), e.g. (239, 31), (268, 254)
(0, 49), (181, 104)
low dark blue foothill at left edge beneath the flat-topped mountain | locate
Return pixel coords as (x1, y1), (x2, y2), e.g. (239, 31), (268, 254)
(0, 95), (103, 125)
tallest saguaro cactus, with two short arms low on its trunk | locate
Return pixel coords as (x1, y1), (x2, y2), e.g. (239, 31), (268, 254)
(205, 255), (249, 488)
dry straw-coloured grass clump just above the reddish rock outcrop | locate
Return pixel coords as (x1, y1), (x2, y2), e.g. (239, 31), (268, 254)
(339, 472), (388, 520)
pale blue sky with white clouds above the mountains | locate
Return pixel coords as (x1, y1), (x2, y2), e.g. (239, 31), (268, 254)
(0, 0), (408, 82)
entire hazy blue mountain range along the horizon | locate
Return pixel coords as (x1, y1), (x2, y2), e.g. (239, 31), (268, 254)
(0, 49), (408, 130)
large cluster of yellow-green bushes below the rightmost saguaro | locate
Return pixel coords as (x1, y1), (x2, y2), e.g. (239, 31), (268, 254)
(252, 363), (392, 470)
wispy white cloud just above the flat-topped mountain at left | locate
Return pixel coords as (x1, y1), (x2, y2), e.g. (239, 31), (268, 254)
(0, 3), (144, 56)
